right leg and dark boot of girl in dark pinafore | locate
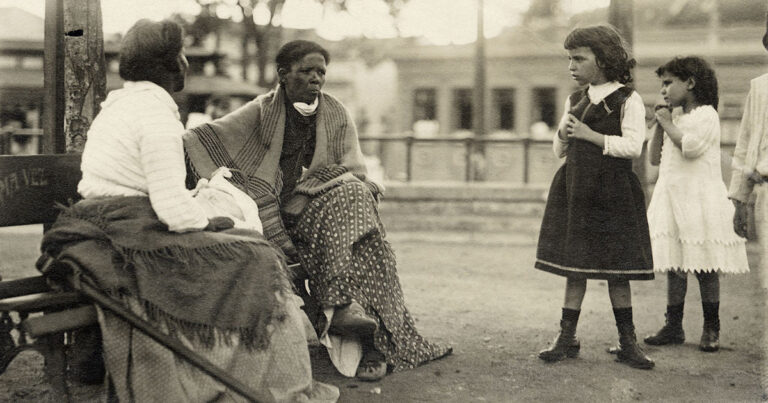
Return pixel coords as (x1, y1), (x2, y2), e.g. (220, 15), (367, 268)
(608, 280), (655, 369)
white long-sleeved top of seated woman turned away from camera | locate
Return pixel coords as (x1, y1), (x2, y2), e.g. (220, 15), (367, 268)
(77, 81), (208, 232)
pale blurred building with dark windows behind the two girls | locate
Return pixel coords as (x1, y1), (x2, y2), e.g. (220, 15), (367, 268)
(378, 26), (768, 184)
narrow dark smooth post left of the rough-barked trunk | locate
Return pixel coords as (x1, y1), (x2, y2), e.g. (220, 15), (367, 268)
(43, 0), (66, 154)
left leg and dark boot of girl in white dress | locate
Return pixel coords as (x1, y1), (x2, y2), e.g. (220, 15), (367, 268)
(644, 271), (688, 346)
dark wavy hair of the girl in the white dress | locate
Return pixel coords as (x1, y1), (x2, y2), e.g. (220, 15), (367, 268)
(656, 56), (719, 110)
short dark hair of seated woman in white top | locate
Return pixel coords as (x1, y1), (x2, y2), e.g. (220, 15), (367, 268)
(119, 19), (184, 85)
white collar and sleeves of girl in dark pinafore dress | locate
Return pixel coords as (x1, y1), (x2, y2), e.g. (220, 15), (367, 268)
(553, 81), (645, 159)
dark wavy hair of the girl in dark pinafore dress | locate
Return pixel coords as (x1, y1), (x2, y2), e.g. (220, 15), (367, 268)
(563, 25), (635, 84)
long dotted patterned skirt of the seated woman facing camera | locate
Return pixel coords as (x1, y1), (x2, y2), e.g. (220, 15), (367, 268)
(290, 182), (451, 372)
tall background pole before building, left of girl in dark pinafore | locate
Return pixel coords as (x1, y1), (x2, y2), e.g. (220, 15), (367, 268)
(467, 0), (485, 180)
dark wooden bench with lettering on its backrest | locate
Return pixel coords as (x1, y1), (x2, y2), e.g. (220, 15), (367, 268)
(0, 155), (96, 396)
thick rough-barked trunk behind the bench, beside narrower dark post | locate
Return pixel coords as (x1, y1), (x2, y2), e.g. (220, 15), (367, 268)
(62, 0), (107, 153)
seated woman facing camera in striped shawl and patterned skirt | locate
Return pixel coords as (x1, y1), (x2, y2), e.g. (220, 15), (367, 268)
(184, 40), (451, 380)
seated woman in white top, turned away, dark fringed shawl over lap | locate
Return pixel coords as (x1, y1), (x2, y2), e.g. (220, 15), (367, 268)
(43, 20), (339, 402)
